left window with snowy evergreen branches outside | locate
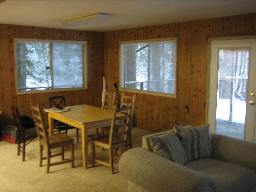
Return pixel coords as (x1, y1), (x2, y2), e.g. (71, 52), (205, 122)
(15, 40), (86, 92)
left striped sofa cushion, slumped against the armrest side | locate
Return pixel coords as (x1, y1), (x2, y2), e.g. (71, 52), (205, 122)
(149, 132), (187, 165)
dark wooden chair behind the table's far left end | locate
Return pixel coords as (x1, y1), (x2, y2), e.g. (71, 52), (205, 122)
(49, 96), (79, 143)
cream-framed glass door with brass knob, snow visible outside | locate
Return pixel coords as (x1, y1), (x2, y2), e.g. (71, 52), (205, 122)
(208, 39), (256, 141)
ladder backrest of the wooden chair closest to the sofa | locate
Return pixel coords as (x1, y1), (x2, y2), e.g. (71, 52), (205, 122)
(109, 105), (132, 145)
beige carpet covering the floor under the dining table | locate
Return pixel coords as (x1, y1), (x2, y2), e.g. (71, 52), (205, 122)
(0, 128), (150, 192)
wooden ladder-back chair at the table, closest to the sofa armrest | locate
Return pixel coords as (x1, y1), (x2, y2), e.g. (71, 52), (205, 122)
(91, 106), (131, 174)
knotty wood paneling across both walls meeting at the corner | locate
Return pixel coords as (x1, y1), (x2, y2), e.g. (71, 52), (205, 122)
(0, 14), (256, 131)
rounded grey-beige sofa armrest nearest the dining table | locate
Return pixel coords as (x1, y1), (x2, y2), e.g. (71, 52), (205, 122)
(119, 148), (214, 192)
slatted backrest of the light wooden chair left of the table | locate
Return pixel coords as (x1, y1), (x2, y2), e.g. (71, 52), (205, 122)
(30, 104), (49, 146)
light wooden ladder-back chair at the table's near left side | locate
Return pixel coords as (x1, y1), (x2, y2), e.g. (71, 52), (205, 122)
(30, 105), (74, 173)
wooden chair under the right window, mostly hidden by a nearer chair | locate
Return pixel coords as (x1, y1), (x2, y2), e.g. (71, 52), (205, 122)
(120, 93), (136, 148)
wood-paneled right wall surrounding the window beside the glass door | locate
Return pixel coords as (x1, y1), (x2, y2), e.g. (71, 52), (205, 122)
(104, 14), (256, 131)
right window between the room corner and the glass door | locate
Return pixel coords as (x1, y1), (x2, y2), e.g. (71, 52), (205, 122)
(120, 40), (176, 95)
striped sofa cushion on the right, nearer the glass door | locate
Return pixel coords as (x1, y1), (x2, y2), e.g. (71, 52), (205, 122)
(176, 125), (211, 161)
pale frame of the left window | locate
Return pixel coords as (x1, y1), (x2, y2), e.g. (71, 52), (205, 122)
(13, 38), (88, 95)
